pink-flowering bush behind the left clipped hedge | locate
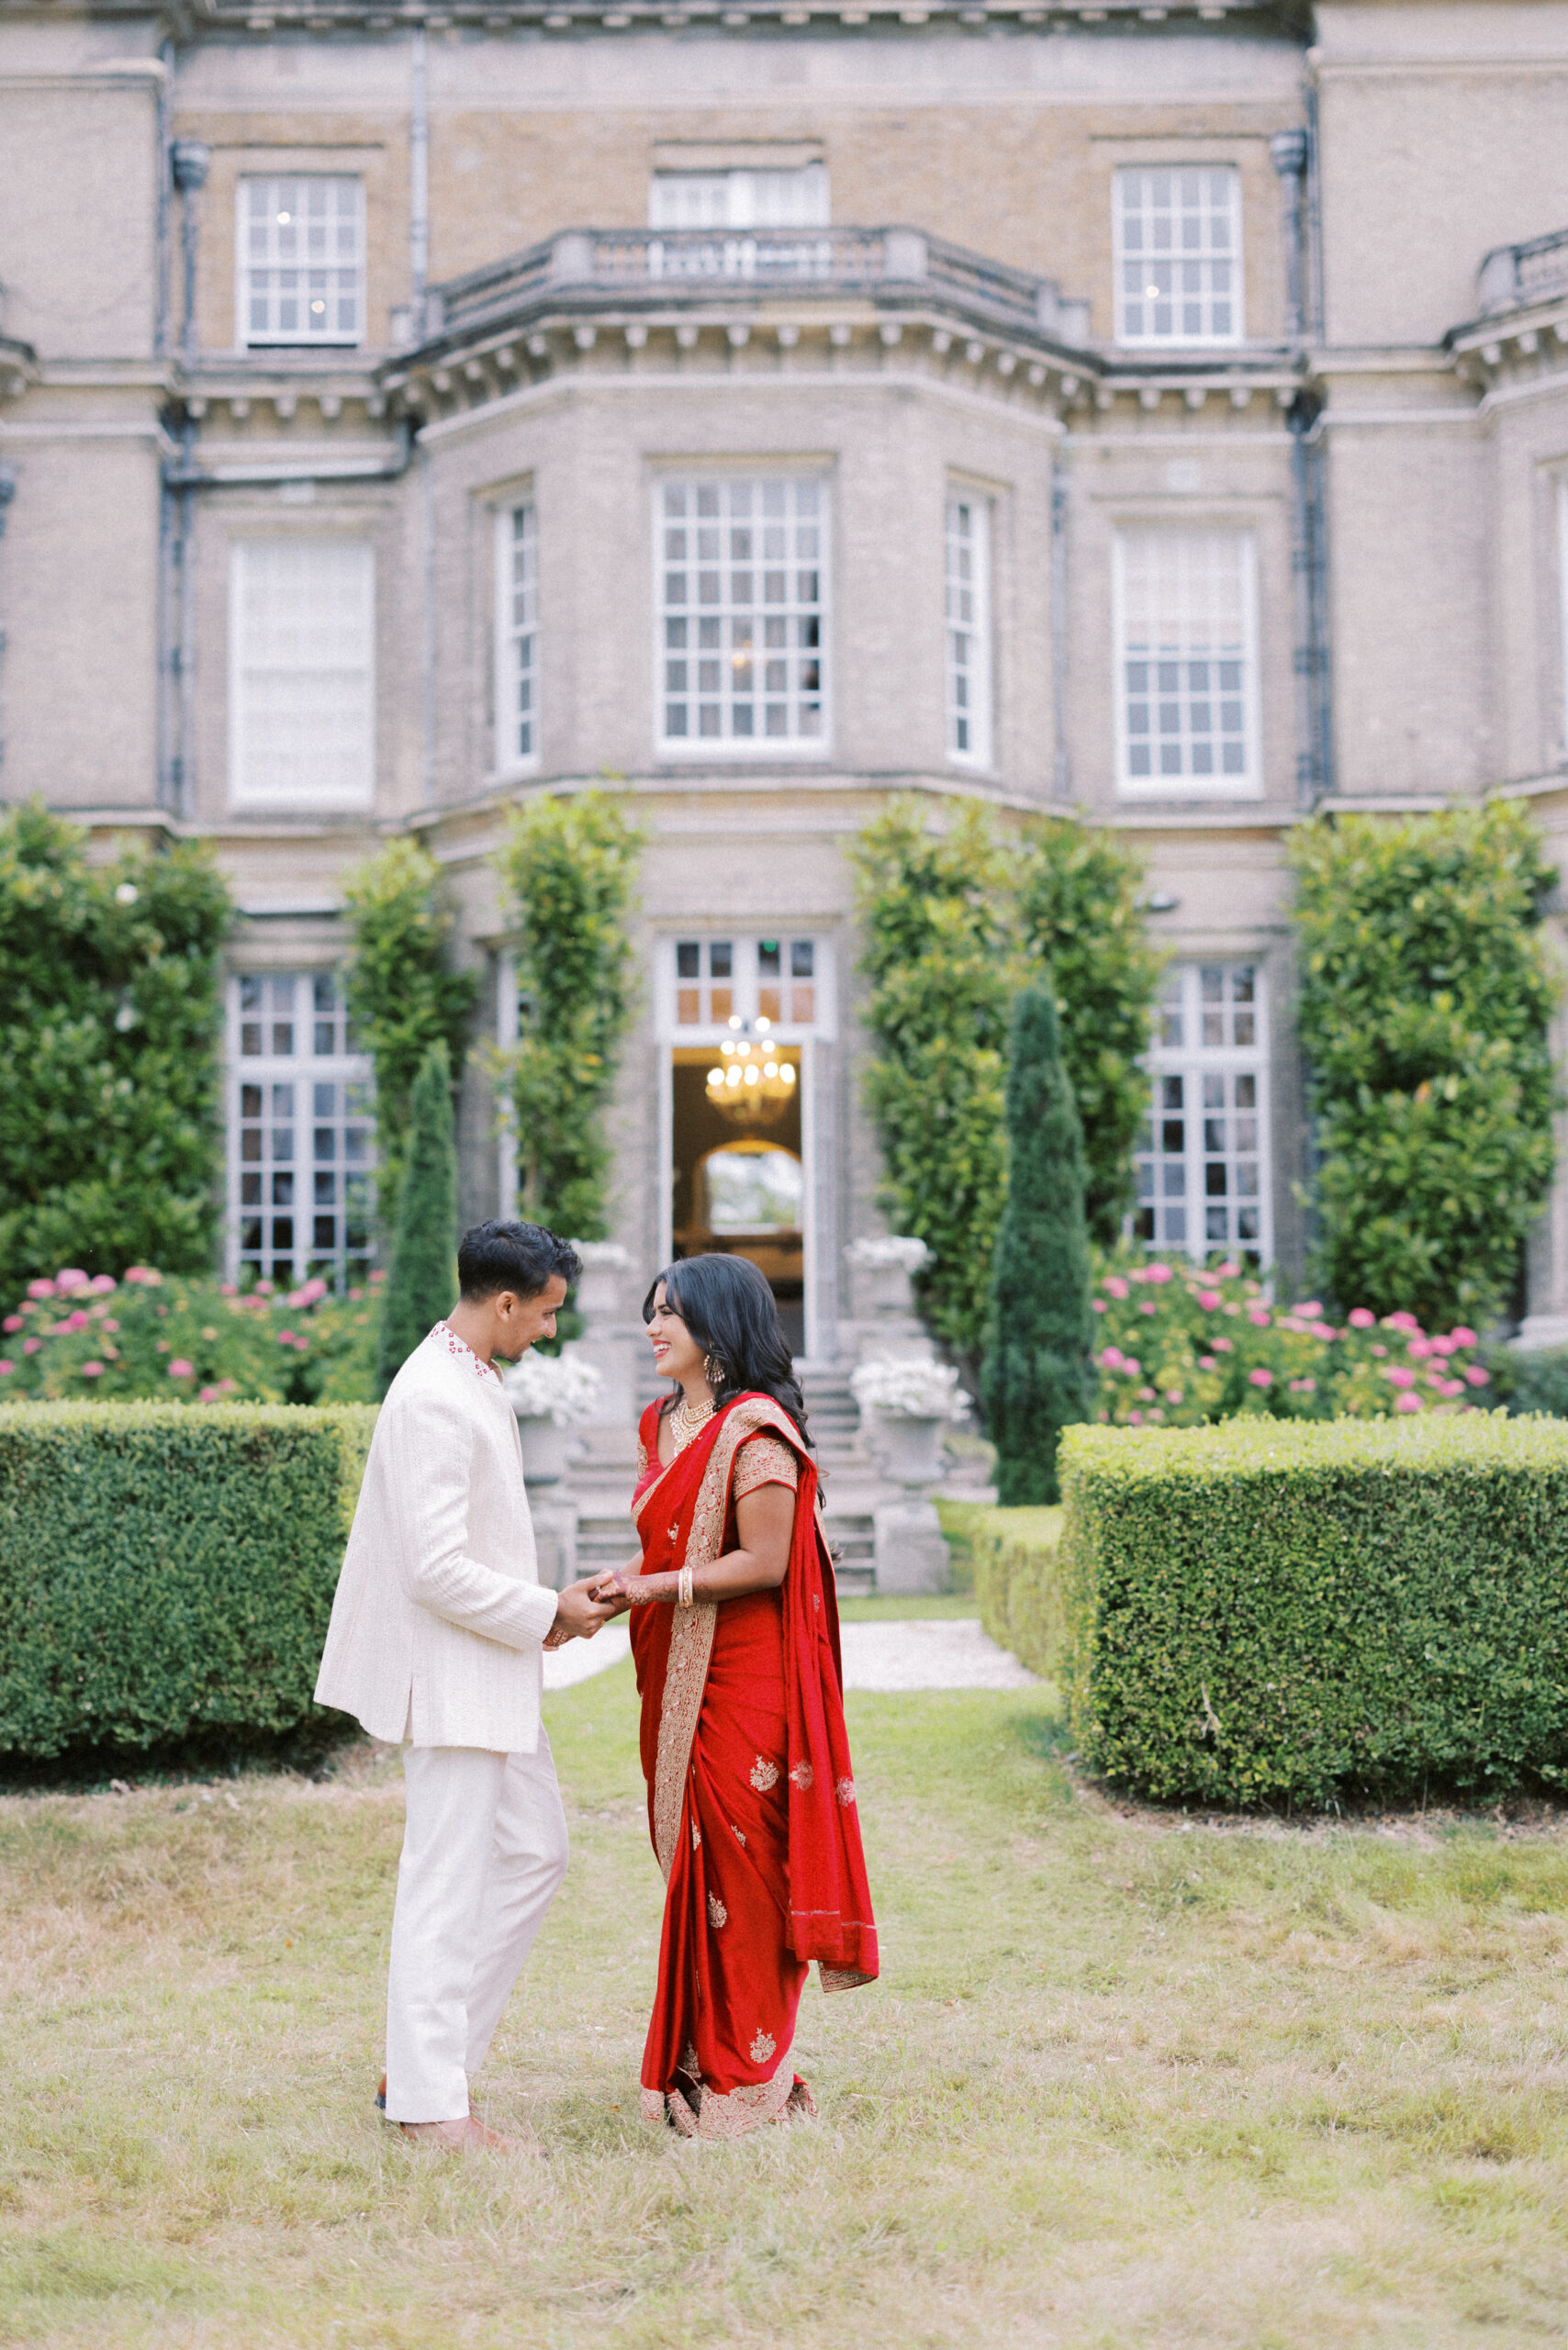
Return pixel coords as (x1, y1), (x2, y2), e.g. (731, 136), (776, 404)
(0, 1264), (381, 1403)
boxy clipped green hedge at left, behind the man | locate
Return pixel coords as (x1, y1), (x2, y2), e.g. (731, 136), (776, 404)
(0, 1403), (376, 1758)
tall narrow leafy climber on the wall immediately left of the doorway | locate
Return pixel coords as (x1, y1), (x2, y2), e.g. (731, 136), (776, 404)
(491, 792), (644, 1241)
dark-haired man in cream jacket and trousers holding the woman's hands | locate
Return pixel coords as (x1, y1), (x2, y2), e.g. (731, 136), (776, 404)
(315, 1225), (609, 2148)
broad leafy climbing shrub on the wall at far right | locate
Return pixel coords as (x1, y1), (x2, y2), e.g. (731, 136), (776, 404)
(1291, 801), (1556, 1323)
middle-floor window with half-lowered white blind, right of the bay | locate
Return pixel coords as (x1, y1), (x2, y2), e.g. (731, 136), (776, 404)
(1112, 529), (1260, 797)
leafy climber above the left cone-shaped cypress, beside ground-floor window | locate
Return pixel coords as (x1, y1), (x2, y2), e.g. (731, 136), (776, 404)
(343, 839), (479, 1229)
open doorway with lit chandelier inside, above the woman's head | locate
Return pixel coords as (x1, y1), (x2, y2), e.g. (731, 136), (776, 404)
(670, 1036), (806, 1356)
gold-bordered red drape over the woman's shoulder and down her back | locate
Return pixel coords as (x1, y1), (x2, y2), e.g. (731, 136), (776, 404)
(630, 1393), (877, 1990)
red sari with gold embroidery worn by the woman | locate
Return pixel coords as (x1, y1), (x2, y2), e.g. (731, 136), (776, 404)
(630, 1393), (877, 2139)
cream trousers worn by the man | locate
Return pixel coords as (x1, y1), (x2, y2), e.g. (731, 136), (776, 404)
(386, 1729), (566, 2122)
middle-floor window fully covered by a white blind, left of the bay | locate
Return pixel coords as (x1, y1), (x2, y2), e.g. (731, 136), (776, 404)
(228, 536), (376, 809)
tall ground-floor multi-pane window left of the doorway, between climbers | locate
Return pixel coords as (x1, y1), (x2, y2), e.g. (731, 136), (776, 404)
(228, 970), (376, 1285)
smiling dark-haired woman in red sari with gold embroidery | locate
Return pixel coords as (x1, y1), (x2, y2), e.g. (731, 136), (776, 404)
(595, 1258), (877, 2139)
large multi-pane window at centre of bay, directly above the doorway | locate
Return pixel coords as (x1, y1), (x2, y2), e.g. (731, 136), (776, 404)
(654, 477), (827, 759)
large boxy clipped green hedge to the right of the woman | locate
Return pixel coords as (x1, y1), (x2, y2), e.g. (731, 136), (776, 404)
(1062, 1413), (1568, 1805)
